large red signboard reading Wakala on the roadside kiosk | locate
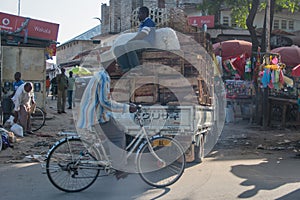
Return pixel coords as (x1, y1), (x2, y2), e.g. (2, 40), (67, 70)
(0, 12), (59, 41)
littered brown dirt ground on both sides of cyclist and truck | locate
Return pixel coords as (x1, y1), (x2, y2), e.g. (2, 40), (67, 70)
(0, 97), (300, 164)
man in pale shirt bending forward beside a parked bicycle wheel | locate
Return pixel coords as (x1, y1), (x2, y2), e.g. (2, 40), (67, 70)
(12, 82), (35, 134)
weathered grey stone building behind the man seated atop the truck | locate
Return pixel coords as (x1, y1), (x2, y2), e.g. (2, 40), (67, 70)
(56, 0), (202, 67)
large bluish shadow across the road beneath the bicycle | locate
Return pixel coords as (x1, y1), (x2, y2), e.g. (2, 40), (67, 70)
(0, 164), (171, 200)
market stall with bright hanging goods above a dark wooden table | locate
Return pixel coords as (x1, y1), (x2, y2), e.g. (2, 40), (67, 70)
(259, 53), (300, 127)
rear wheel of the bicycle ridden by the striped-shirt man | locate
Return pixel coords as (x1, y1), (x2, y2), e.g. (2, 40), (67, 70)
(46, 138), (100, 192)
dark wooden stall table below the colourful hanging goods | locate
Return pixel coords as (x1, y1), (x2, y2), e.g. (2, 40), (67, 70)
(268, 97), (300, 127)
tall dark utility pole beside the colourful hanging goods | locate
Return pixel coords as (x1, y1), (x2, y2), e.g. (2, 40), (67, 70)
(263, 0), (271, 129)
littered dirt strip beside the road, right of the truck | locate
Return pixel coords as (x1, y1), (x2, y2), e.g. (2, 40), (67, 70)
(211, 120), (300, 158)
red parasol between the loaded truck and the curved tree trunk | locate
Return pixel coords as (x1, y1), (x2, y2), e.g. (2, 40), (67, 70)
(213, 40), (252, 60)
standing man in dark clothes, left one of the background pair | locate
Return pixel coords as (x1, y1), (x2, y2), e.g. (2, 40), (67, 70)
(56, 68), (68, 114)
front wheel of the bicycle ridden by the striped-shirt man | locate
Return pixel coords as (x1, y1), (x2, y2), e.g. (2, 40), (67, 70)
(137, 136), (185, 188)
